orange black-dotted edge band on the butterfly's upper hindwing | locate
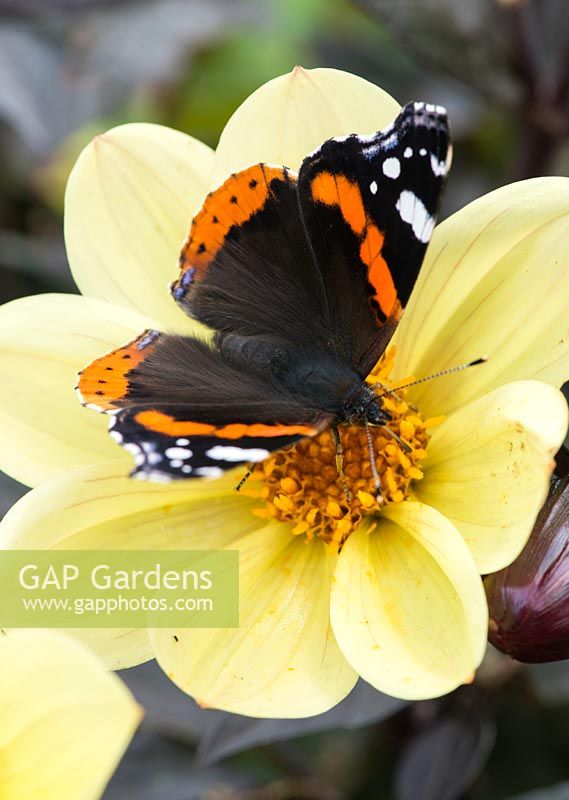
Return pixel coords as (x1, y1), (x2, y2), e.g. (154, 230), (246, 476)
(174, 164), (293, 286)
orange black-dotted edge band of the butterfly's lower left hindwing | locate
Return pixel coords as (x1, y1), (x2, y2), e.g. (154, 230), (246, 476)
(76, 331), (158, 411)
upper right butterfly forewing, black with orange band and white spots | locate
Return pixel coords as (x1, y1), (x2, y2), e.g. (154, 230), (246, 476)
(298, 103), (451, 374)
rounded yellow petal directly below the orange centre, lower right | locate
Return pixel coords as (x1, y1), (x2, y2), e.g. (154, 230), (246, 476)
(331, 502), (488, 700)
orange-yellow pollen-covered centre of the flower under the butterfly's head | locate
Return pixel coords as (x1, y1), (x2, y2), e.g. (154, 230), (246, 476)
(251, 348), (434, 549)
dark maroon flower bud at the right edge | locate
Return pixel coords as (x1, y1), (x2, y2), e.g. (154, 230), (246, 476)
(484, 476), (569, 663)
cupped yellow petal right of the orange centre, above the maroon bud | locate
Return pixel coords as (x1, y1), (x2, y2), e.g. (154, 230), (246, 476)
(416, 381), (567, 574)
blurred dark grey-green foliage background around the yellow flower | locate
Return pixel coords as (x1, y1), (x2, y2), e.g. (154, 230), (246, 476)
(0, 0), (569, 800)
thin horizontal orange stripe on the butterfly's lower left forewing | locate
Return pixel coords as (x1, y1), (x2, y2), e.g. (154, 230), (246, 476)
(134, 411), (318, 439)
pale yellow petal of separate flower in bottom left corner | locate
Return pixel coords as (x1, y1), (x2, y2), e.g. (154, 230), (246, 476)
(0, 631), (141, 800)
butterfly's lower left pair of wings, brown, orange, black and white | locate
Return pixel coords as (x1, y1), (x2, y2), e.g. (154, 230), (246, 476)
(77, 331), (331, 481)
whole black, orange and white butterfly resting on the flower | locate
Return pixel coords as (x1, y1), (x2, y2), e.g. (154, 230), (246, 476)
(77, 103), (451, 481)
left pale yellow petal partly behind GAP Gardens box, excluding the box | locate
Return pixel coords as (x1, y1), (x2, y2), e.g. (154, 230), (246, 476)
(0, 462), (263, 669)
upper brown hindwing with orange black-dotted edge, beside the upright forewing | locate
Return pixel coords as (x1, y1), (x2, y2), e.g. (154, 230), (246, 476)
(171, 164), (336, 354)
